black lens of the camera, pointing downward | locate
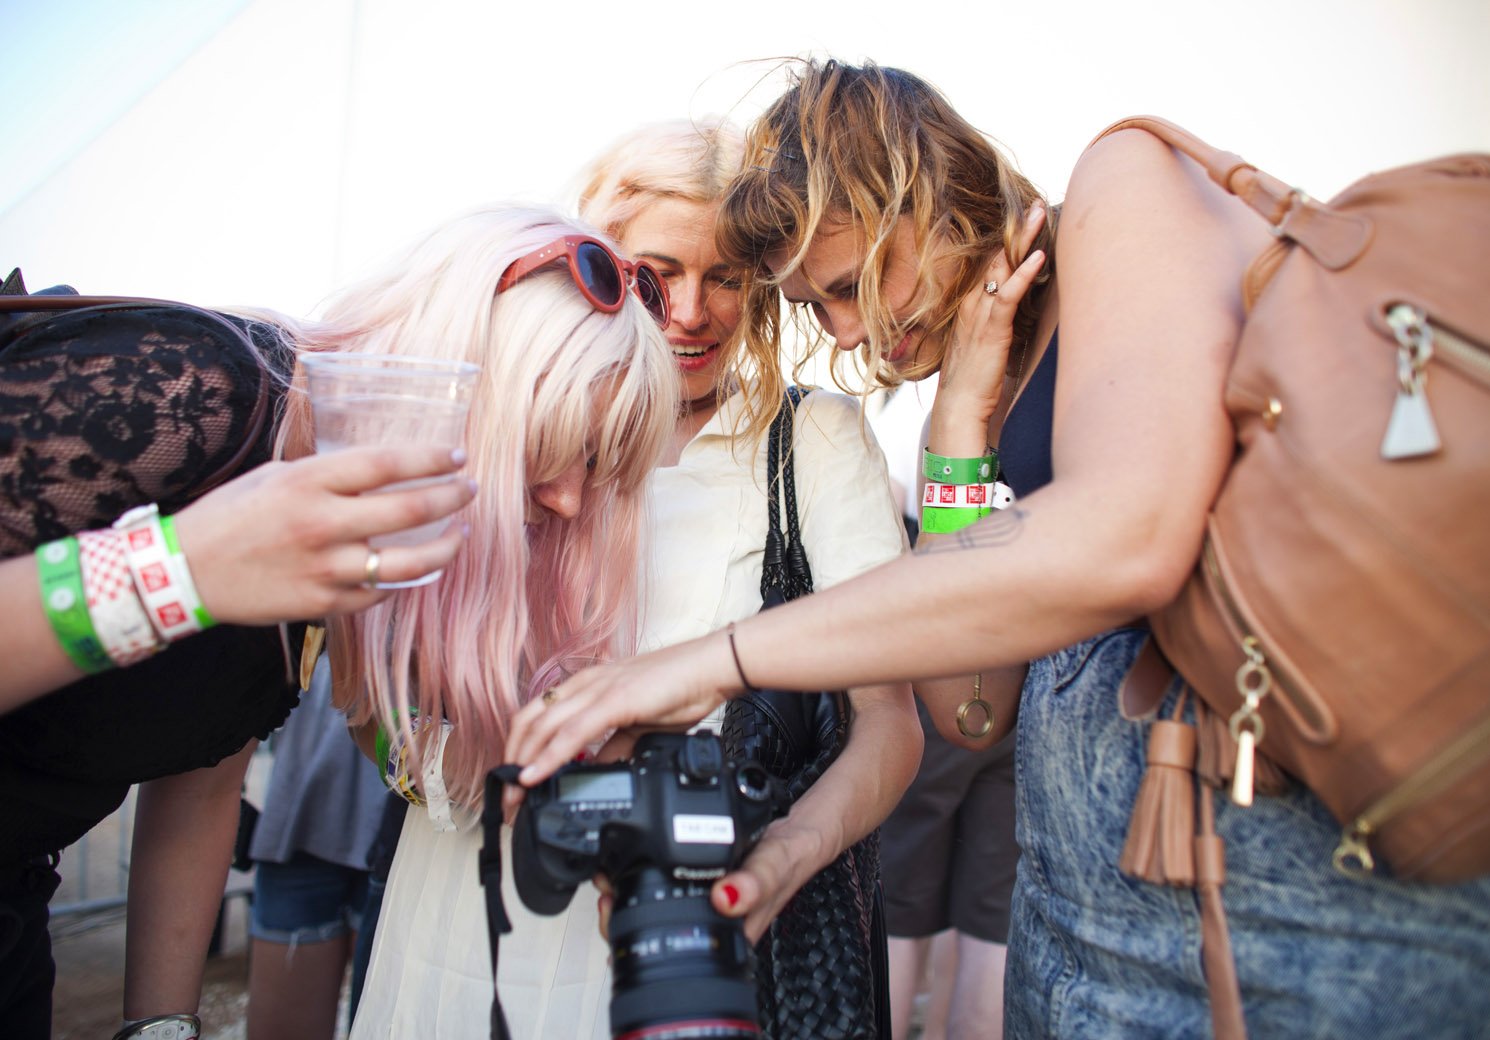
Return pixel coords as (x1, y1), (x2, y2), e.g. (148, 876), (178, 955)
(611, 867), (760, 1040)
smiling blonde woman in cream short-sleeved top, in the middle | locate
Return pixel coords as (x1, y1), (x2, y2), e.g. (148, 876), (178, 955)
(580, 119), (921, 1037)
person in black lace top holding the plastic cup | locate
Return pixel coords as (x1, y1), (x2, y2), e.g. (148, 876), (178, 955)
(0, 273), (474, 1037)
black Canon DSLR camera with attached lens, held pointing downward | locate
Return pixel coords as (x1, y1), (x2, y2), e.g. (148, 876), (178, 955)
(500, 733), (788, 1040)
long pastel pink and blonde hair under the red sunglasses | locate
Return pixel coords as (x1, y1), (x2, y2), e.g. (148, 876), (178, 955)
(271, 207), (678, 805)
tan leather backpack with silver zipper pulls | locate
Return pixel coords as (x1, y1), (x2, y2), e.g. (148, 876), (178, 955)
(1100, 118), (1490, 882)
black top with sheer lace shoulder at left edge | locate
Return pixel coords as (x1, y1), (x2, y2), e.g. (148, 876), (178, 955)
(0, 293), (298, 863)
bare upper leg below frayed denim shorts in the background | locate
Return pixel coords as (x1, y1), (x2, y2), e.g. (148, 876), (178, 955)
(247, 934), (353, 1040)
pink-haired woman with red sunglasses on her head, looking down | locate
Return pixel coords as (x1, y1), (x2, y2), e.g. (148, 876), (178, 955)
(295, 207), (676, 1037)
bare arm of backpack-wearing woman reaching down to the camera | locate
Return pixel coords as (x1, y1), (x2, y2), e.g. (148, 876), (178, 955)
(508, 131), (1267, 784)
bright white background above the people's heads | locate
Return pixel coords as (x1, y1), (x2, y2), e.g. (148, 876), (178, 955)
(0, 0), (1490, 313)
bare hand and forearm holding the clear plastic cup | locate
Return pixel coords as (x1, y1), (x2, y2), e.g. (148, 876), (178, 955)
(0, 447), (475, 712)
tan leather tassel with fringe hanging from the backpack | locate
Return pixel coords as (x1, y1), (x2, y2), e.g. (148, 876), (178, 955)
(1118, 694), (1195, 887)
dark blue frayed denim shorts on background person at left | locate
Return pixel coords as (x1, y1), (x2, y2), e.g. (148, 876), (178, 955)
(249, 852), (368, 946)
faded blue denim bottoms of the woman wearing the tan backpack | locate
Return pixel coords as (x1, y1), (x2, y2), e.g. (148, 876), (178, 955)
(1006, 629), (1490, 1040)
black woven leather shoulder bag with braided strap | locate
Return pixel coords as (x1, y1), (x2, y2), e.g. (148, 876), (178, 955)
(721, 387), (890, 1040)
